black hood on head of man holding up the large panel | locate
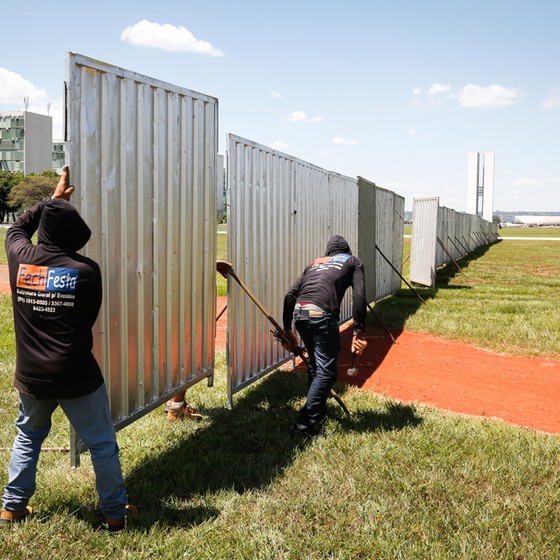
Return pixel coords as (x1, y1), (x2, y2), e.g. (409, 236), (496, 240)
(38, 198), (91, 251)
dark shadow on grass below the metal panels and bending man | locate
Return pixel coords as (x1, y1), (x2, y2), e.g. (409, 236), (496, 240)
(118, 371), (422, 530)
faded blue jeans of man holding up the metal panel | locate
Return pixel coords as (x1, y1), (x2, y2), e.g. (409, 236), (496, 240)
(2, 384), (127, 518)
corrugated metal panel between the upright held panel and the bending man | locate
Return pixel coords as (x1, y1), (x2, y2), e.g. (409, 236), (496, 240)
(227, 134), (297, 398)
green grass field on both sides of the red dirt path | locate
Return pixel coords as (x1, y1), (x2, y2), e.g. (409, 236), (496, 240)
(0, 225), (560, 560)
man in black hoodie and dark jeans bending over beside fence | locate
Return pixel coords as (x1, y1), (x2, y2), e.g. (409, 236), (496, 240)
(283, 235), (367, 437)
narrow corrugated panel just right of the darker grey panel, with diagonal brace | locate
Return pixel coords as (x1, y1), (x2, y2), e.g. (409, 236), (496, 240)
(375, 187), (404, 300)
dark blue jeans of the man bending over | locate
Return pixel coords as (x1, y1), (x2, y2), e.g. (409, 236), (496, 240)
(294, 314), (340, 426)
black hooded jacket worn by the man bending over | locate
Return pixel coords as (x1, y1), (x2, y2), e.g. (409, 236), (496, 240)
(283, 235), (366, 331)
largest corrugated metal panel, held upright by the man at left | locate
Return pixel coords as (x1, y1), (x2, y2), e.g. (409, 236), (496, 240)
(67, 53), (218, 427)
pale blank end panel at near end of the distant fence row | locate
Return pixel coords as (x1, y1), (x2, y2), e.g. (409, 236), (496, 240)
(410, 197), (442, 286)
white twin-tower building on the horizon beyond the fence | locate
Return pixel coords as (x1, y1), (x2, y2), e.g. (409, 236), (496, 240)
(467, 152), (494, 222)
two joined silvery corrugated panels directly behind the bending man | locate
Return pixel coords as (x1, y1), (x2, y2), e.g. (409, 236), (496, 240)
(227, 134), (358, 404)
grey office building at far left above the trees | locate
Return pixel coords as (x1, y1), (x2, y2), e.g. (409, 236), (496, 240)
(0, 111), (53, 175)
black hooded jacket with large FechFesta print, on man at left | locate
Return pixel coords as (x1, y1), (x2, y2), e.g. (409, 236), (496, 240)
(6, 198), (103, 399)
